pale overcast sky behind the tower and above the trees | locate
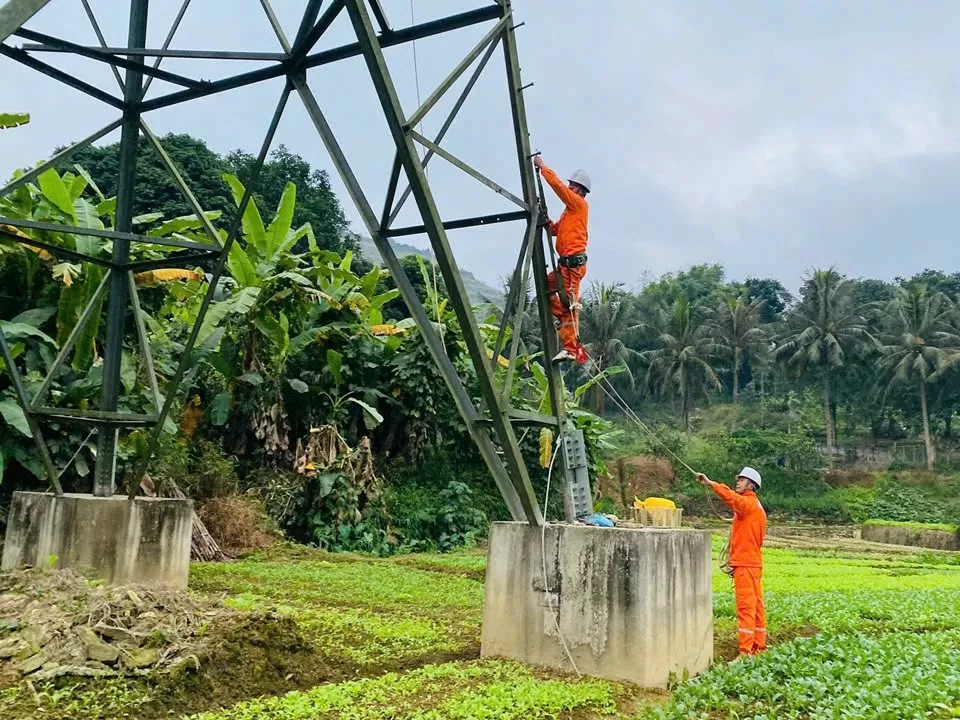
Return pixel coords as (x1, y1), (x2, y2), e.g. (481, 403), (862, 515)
(0, 0), (960, 288)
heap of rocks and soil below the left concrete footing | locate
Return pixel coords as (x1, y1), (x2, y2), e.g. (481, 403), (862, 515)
(0, 570), (231, 686)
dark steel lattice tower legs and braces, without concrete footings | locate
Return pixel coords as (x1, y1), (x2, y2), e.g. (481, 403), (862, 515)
(0, 0), (585, 525)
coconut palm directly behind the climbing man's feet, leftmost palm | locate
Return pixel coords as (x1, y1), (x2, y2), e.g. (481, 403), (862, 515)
(580, 283), (640, 415)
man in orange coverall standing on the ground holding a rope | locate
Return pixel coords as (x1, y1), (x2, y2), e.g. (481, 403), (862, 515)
(697, 467), (767, 655)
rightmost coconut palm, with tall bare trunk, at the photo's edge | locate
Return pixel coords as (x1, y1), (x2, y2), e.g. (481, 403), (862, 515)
(880, 285), (960, 471)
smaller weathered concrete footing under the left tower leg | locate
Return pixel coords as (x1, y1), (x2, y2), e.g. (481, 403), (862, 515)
(0, 492), (193, 588)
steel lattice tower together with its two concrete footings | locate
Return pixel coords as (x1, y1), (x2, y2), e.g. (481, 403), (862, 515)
(0, 0), (712, 684)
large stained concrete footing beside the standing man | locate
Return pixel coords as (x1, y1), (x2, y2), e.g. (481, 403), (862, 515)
(481, 523), (713, 688)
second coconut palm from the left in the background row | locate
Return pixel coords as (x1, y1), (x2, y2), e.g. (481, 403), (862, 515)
(641, 298), (722, 440)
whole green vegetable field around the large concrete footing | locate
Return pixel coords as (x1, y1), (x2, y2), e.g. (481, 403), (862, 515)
(0, 538), (960, 720)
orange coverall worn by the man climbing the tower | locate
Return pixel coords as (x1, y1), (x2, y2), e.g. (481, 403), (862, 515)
(540, 166), (589, 354)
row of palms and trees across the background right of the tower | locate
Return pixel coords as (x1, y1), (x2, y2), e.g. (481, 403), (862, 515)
(568, 265), (960, 469)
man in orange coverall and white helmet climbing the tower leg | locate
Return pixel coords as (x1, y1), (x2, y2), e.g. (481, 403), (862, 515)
(533, 155), (590, 362)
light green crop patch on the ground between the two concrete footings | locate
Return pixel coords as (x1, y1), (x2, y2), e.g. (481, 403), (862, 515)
(191, 553), (483, 668)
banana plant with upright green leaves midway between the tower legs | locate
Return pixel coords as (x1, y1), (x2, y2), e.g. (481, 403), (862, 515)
(199, 175), (401, 434)
